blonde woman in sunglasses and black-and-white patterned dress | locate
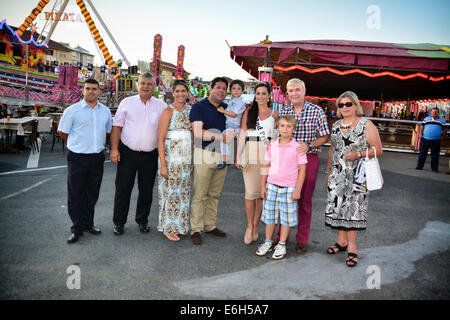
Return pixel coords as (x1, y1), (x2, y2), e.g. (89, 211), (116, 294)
(325, 91), (382, 267)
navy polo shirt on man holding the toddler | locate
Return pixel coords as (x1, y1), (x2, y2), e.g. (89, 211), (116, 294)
(189, 98), (227, 149)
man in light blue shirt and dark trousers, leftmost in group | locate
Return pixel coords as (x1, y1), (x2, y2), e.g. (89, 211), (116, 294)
(58, 79), (112, 243)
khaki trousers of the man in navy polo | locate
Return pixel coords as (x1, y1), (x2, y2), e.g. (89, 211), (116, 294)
(191, 148), (227, 234)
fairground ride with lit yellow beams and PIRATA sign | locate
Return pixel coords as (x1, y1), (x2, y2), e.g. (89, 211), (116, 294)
(0, 0), (130, 104)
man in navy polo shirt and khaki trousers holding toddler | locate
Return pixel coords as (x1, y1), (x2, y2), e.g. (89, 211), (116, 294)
(189, 77), (234, 245)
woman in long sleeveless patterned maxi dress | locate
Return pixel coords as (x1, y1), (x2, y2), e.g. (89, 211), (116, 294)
(158, 80), (192, 241)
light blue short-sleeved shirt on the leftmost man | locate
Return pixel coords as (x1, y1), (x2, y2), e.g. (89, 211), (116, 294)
(58, 99), (112, 153)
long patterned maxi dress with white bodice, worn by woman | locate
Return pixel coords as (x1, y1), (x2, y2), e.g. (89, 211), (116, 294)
(158, 105), (193, 234)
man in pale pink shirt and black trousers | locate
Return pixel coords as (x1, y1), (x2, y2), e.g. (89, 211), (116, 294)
(110, 72), (167, 235)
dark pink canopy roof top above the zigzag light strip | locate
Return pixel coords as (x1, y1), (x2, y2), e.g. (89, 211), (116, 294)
(231, 40), (450, 71)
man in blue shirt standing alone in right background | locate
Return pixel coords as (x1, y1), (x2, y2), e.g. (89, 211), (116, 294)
(416, 108), (446, 172)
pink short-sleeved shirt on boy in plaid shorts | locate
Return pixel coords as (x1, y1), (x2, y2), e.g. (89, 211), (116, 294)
(264, 138), (308, 187)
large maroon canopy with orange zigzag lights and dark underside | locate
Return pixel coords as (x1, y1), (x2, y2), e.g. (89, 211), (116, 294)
(230, 40), (450, 100)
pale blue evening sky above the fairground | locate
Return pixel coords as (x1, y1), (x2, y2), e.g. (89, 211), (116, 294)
(0, 0), (450, 81)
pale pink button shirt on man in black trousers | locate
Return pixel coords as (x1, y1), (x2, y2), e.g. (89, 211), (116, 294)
(113, 95), (167, 152)
